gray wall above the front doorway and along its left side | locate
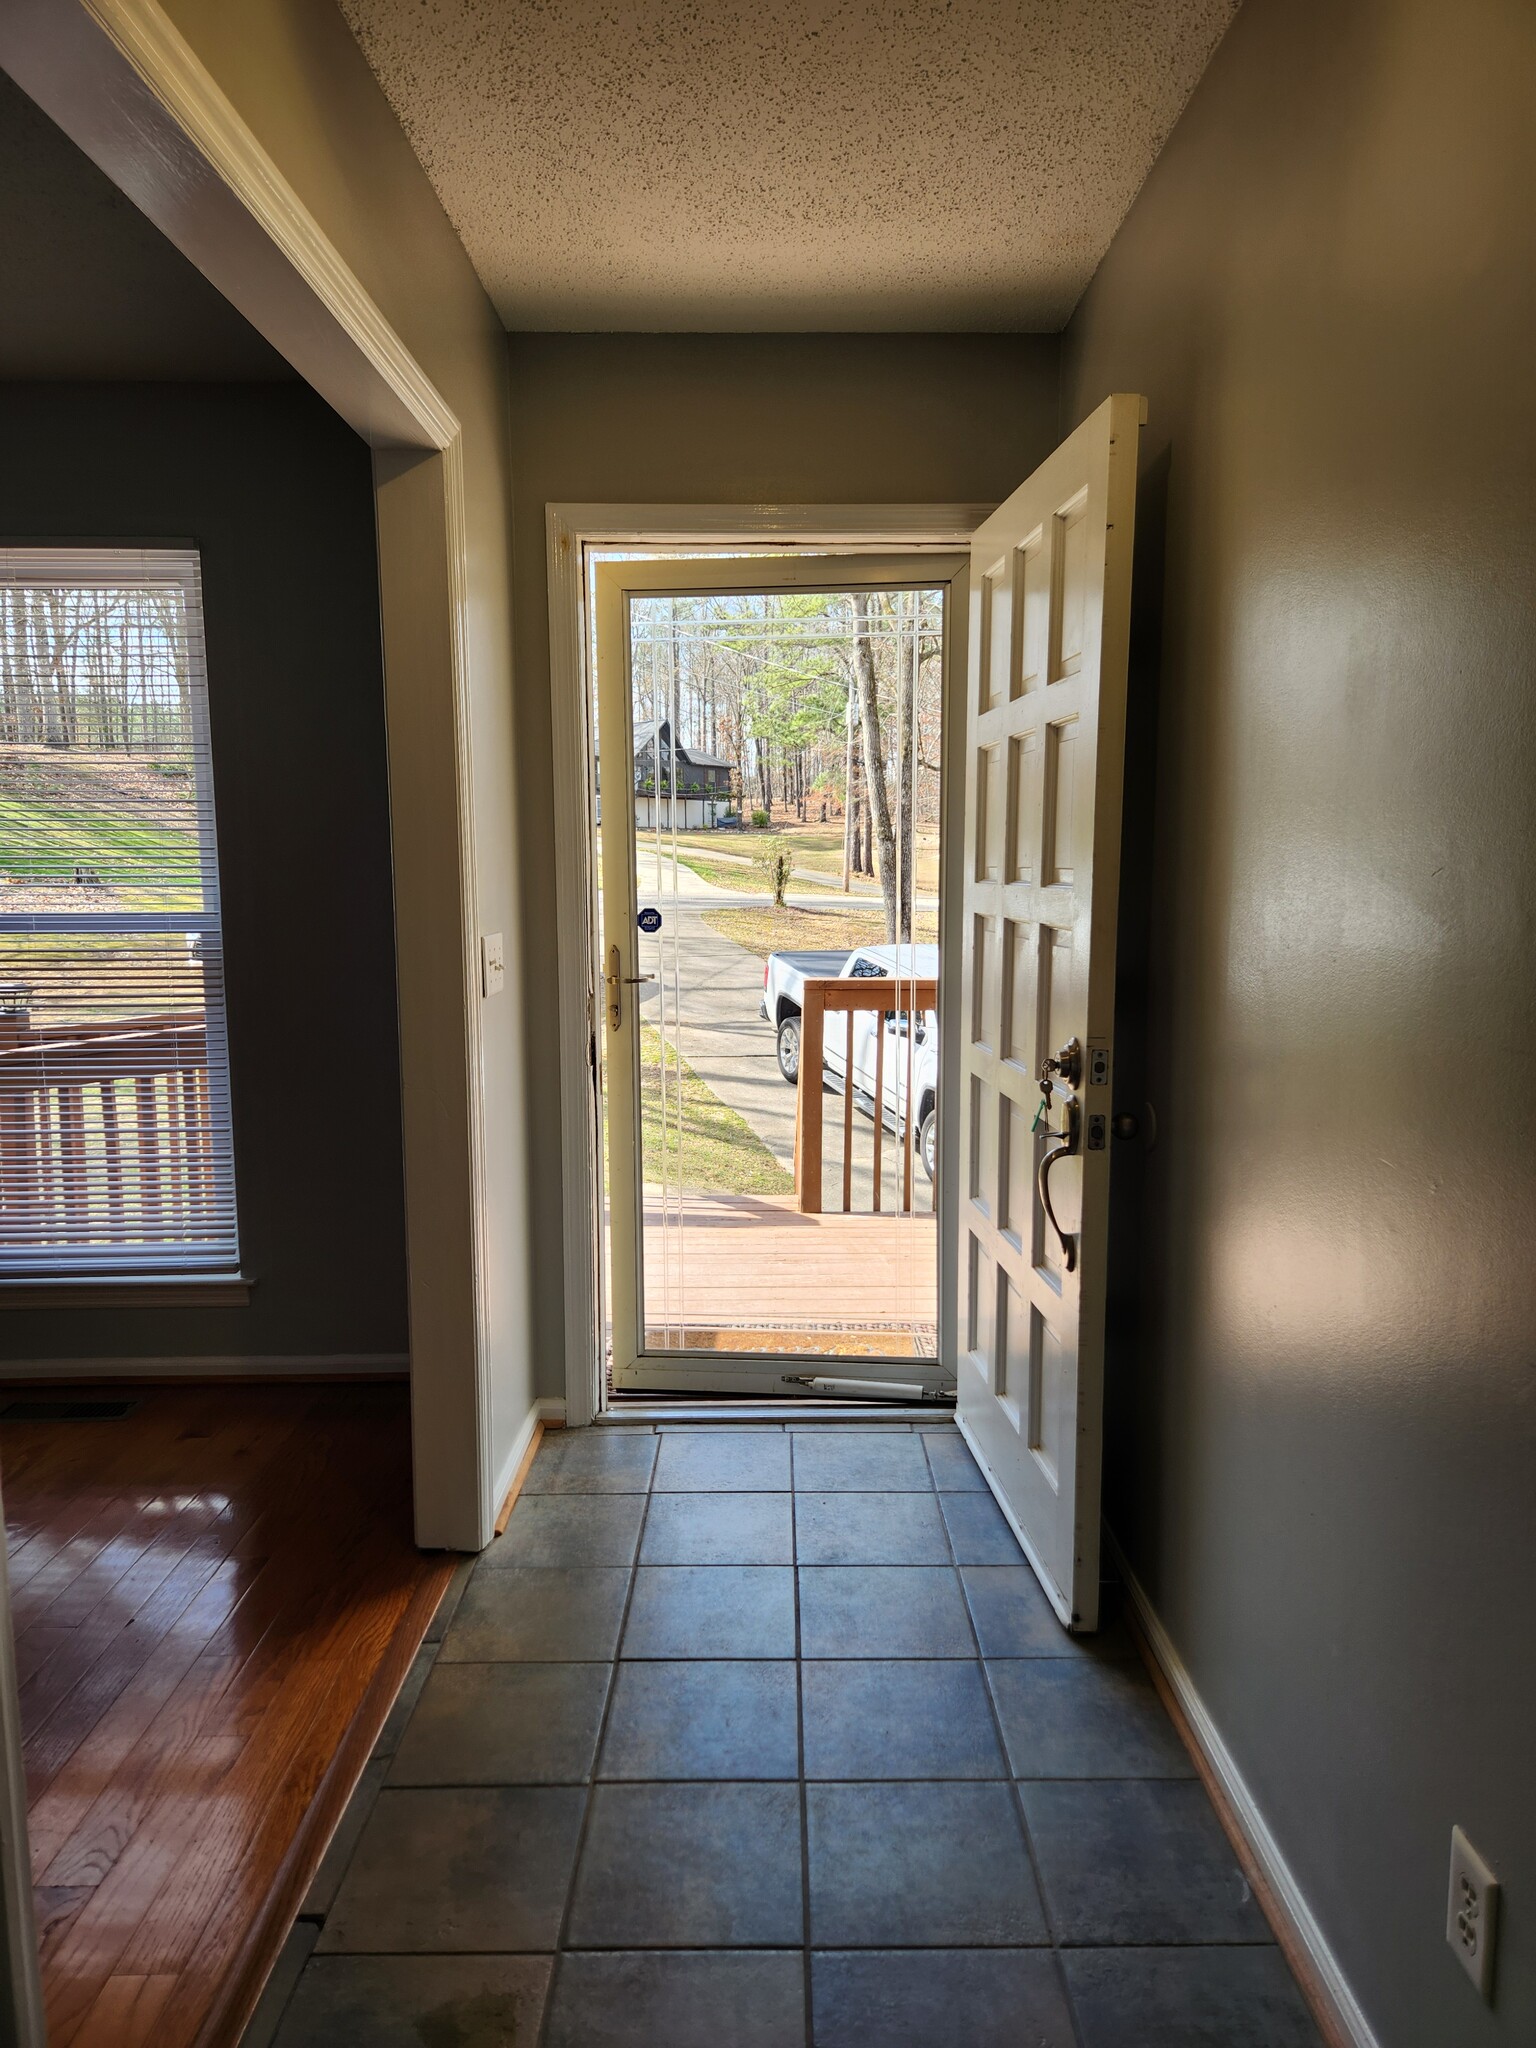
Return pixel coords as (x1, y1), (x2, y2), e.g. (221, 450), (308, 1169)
(508, 334), (1057, 1395)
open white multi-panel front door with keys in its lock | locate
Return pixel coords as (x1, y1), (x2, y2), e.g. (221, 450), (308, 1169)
(958, 395), (1145, 1630)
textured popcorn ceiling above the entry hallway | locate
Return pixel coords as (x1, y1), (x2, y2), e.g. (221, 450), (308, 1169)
(340, 0), (1237, 332)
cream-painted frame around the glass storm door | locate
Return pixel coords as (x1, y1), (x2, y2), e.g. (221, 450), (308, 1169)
(545, 504), (993, 1425)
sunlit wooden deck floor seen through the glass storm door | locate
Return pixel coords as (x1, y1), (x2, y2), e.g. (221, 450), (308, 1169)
(645, 1192), (938, 1358)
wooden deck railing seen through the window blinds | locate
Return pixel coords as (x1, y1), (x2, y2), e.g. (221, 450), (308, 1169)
(0, 1010), (221, 1260)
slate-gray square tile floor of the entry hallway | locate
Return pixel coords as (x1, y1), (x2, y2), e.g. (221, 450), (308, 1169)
(246, 1425), (1319, 2048)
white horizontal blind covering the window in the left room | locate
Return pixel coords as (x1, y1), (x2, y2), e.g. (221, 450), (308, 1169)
(0, 547), (240, 1278)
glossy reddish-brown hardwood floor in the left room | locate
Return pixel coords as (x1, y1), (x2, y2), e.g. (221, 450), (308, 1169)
(0, 1384), (453, 2048)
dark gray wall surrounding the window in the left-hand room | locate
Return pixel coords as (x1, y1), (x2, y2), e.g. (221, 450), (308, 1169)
(0, 383), (408, 1360)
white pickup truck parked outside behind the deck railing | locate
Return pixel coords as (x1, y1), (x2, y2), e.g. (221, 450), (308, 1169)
(762, 946), (938, 1180)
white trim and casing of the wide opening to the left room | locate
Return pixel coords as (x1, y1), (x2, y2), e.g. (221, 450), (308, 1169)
(0, 0), (496, 1550)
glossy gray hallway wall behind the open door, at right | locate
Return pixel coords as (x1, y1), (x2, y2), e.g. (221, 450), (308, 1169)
(1061, 0), (1536, 2048)
